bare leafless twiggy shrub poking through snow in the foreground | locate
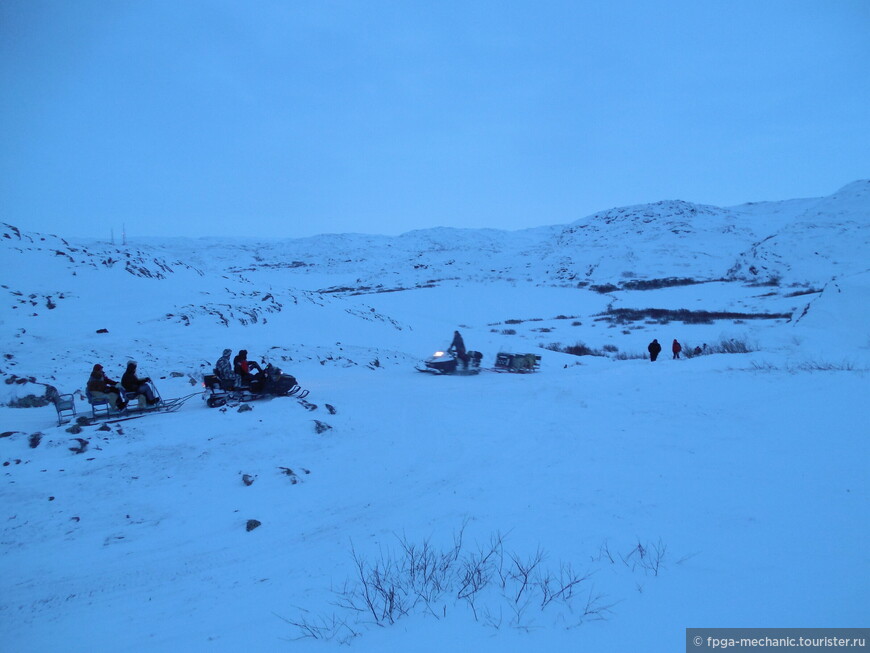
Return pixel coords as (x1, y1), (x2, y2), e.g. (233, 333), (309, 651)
(281, 526), (667, 643)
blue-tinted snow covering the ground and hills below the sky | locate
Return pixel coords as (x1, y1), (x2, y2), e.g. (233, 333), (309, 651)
(0, 181), (870, 652)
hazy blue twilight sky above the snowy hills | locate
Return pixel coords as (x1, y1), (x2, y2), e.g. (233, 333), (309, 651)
(0, 0), (870, 237)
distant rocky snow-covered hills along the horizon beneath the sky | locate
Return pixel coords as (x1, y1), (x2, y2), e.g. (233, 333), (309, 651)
(0, 180), (870, 292)
